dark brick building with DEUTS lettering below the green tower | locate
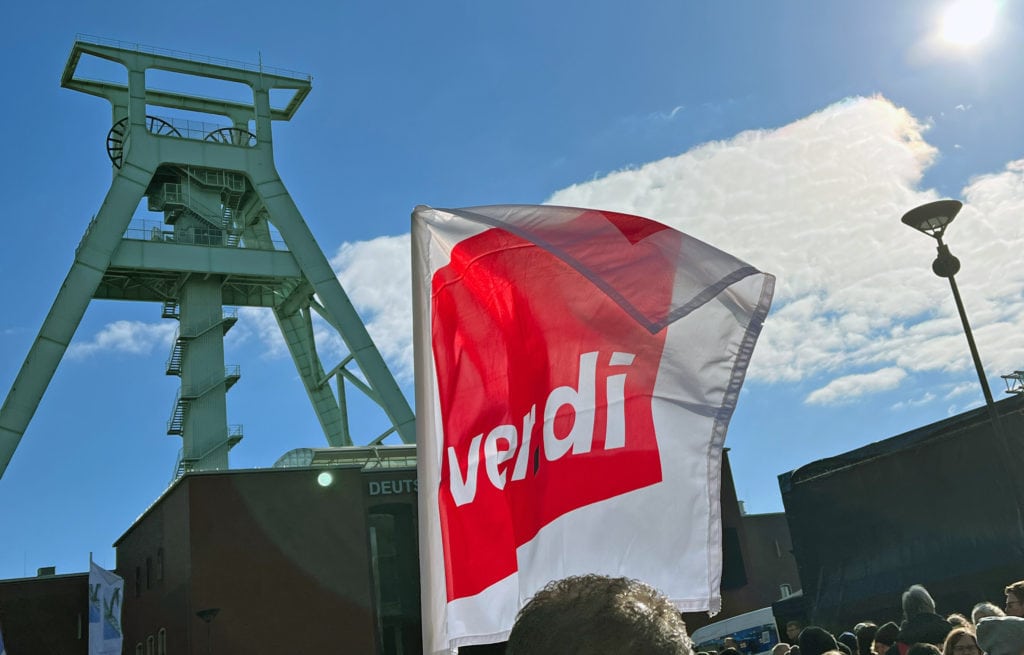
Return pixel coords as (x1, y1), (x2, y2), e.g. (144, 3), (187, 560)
(115, 448), (420, 655)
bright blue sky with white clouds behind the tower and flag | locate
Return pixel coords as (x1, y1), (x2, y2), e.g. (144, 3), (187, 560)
(0, 0), (1024, 578)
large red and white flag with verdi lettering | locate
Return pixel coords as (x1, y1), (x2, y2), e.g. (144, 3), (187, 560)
(413, 206), (774, 654)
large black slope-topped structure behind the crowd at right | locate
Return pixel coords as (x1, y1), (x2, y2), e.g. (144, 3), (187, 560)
(779, 396), (1024, 629)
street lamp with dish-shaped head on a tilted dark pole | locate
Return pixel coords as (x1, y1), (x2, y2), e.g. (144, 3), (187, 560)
(901, 200), (1010, 438)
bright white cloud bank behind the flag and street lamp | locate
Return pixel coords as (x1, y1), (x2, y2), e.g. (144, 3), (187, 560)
(74, 97), (1024, 403)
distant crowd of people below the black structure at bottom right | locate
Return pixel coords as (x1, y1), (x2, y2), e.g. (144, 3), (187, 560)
(770, 580), (1024, 655)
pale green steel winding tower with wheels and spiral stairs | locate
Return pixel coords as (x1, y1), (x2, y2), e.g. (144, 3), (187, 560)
(0, 37), (415, 476)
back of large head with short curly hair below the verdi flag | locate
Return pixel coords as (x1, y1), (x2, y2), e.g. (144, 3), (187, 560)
(506, 574), (693, 655)
